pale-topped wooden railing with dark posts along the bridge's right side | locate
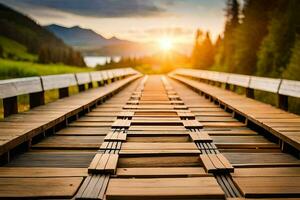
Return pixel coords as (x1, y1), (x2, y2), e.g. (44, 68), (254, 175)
(171, 69), (300, 110)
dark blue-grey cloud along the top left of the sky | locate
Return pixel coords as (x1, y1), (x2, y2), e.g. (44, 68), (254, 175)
(1, 0), (166, 18)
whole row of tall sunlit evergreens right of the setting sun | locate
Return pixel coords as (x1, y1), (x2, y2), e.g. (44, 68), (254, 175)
(191, 0), (300, 80)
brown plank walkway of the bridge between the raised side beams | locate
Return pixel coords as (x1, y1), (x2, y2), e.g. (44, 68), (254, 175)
(0, 75), (300, 200)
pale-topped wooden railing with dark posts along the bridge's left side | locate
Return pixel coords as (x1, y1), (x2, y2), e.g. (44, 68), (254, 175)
(0, 68), (138, 117)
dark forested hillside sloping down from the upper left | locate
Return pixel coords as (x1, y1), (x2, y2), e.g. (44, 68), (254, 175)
(0, 4), (85, 66)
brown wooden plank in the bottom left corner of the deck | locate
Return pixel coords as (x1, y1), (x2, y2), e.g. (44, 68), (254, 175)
(0, 177), (83, 199)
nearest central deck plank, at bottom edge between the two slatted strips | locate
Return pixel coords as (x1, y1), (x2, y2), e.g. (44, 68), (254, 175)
(106, 177), (225, 200)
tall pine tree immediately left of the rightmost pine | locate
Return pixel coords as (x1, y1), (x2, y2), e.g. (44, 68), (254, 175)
(232, 0), (276, 75)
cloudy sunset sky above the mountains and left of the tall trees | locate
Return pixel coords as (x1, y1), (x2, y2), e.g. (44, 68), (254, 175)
(0, 0), (225, 43)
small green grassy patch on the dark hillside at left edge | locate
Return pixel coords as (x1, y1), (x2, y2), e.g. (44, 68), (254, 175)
(0, 36), (38, 62)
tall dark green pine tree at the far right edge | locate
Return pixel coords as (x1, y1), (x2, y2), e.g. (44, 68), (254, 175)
(257, 0), (300, 77)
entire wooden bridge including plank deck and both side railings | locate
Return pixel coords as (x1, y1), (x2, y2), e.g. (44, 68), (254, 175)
(0, 69), (300, 200)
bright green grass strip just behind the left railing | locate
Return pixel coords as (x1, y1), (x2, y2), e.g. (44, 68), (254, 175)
(0, 59), (93, 80)
